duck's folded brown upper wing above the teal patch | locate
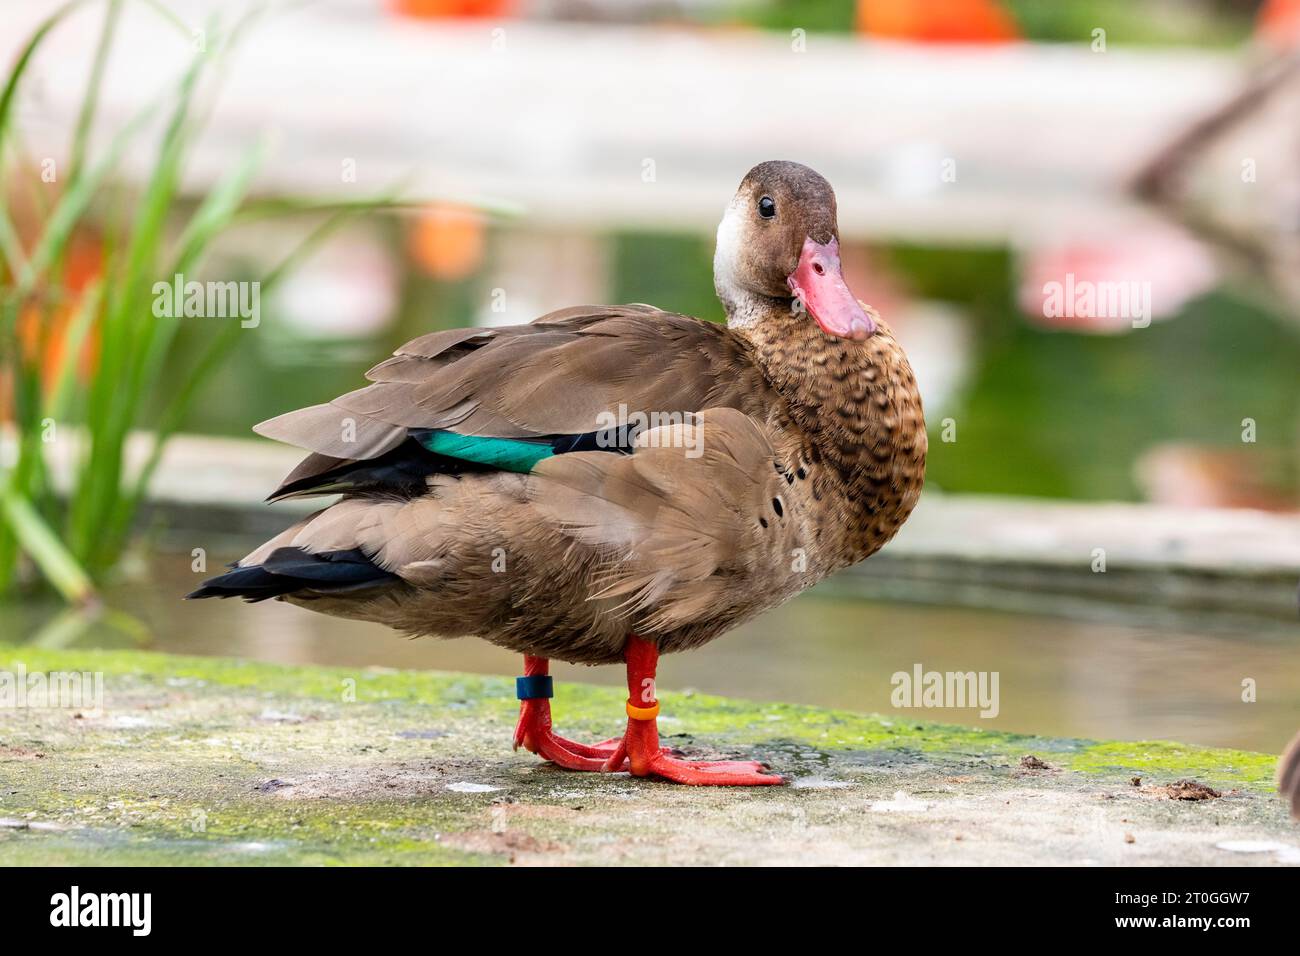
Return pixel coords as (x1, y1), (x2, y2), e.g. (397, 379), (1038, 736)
(255, 306), (768, 496)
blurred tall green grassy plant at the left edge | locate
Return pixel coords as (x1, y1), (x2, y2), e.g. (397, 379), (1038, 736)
(0, 0), (436, 604)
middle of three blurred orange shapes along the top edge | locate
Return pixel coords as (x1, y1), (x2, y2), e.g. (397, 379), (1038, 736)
(858, 0), (1021, 43)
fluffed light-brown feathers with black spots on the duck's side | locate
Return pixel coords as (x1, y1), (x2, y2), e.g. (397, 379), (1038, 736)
(528, 408), (810, 633)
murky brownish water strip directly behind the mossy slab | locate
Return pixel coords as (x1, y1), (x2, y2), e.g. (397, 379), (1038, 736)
(0, 555), (1300, 752)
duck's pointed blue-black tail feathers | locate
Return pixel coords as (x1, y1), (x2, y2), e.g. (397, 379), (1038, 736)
(186, 548), (397, 601)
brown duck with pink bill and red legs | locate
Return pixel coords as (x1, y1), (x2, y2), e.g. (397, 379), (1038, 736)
(189, 161), (927, 786)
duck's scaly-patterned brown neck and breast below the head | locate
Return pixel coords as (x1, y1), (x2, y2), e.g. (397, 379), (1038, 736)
(723, 297), (927, 563)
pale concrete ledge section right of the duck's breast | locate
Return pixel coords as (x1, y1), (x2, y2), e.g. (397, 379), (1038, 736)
(833, 493), (1300, 624)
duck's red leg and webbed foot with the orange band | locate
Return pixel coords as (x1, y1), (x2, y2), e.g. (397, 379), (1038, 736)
(605, 635), (785, 787)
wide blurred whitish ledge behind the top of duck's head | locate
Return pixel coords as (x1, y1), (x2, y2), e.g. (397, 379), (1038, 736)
(0, 0), (1245, 243)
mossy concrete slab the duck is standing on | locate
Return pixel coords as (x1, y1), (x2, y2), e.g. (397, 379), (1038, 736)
(0, 645), (1300, 865)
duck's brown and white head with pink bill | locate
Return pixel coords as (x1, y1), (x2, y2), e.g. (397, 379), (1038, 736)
(714, 161), (876, 341)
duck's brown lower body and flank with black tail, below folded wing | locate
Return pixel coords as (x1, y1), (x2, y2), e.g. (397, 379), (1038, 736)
(191, 408), (800, 663)
